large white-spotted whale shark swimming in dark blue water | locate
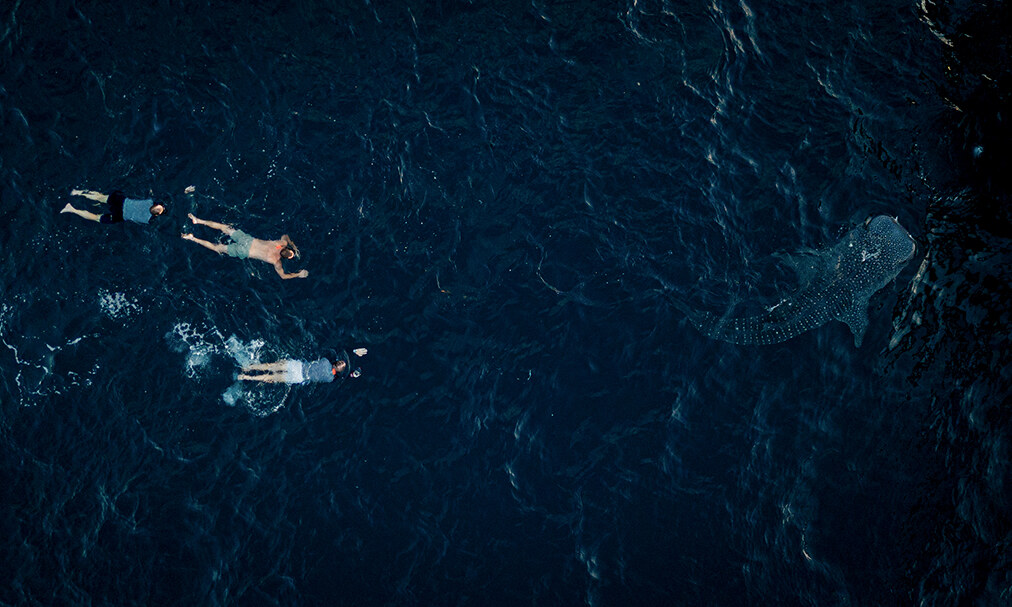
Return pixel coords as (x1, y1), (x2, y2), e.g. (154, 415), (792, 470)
(686, 215), (916, 347)
